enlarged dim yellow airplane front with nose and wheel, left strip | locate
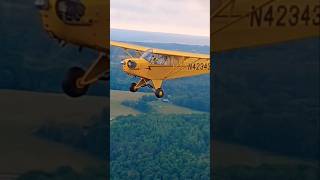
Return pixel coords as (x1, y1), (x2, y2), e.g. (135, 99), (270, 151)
(35, 0), (110, 97)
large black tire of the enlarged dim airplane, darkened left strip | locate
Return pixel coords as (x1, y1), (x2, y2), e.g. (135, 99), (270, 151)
(62, 67), (89, 97)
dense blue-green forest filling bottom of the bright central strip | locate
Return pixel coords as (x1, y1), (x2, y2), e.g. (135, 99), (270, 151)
(110, 113), (210, 180)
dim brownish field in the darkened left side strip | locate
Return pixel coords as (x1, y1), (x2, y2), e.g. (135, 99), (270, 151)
(0, 90), (108, 174)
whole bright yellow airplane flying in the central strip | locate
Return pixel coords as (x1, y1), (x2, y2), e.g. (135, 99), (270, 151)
(110, 41), (210, 98)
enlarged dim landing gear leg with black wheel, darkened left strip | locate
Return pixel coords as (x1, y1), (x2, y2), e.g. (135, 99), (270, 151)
(62, 54), (110, 97)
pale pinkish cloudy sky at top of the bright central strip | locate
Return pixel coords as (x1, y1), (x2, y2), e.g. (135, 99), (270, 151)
(110, 0), (210, 37)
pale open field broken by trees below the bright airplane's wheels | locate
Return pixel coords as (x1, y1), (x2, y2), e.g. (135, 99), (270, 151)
(110, 90), (201, 120)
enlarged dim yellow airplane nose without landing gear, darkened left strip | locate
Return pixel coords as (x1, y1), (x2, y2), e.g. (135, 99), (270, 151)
(35, 0), (109, 52)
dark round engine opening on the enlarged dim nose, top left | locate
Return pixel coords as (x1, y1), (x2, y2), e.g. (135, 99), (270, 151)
(56, 0), (86, 23)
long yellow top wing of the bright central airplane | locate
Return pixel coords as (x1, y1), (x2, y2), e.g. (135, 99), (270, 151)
(110, 41), (210, 59)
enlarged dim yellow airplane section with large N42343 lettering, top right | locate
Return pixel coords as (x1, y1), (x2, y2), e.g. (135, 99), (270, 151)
(211, 0), (320, 52)
